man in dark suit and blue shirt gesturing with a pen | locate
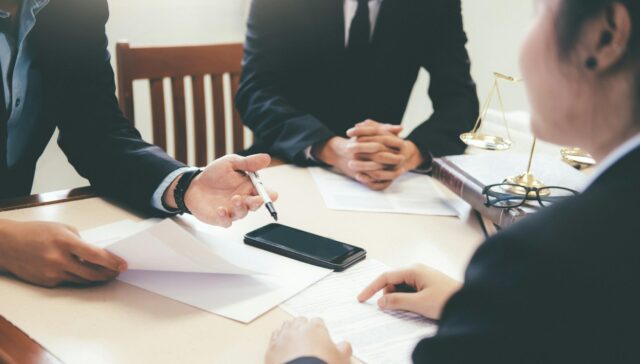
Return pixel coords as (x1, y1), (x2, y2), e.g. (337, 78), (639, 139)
(0, 0), (276, 286)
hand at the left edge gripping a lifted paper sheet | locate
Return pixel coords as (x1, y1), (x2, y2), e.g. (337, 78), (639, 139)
(0, 220), (127, 287)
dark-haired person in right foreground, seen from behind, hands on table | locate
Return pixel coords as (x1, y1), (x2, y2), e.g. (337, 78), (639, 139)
(266, 0), (640, 363)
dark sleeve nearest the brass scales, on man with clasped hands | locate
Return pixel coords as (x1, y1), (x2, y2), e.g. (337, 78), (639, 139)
(408, 0), (479, 157)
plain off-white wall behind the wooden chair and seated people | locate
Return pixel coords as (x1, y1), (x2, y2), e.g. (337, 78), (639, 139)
(33, 0), (534, 193)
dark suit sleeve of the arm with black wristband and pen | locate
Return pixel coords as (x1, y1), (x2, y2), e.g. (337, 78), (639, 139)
(47, 0), (184, 210)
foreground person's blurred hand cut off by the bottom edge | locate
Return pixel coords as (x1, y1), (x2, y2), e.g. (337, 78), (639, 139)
(265, 317), (351, 364)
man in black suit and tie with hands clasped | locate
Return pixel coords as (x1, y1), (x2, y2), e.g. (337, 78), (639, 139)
(237, 0), (478, 189)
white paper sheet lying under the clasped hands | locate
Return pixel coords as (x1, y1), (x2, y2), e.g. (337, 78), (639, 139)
(309, 168), (458, 216)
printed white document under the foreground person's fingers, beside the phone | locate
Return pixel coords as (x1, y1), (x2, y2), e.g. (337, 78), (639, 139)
(281, 259), (437, 364)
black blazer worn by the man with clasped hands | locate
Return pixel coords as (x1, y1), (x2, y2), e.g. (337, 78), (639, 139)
(236, 0), (478, 164)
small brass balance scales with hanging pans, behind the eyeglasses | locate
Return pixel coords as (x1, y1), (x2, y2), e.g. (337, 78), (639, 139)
(460, 72), (595, 197)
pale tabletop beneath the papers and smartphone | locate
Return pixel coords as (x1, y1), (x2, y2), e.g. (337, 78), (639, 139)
(0, 166), (484, 363)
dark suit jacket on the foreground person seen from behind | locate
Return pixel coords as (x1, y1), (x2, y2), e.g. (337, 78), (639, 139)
(413, 144), (640, 363)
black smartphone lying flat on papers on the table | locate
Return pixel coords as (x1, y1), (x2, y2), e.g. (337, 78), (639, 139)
(244, 224), (367, 272)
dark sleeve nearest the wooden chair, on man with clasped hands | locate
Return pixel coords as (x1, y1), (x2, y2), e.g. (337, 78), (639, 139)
(236, 0), (334, 165)
